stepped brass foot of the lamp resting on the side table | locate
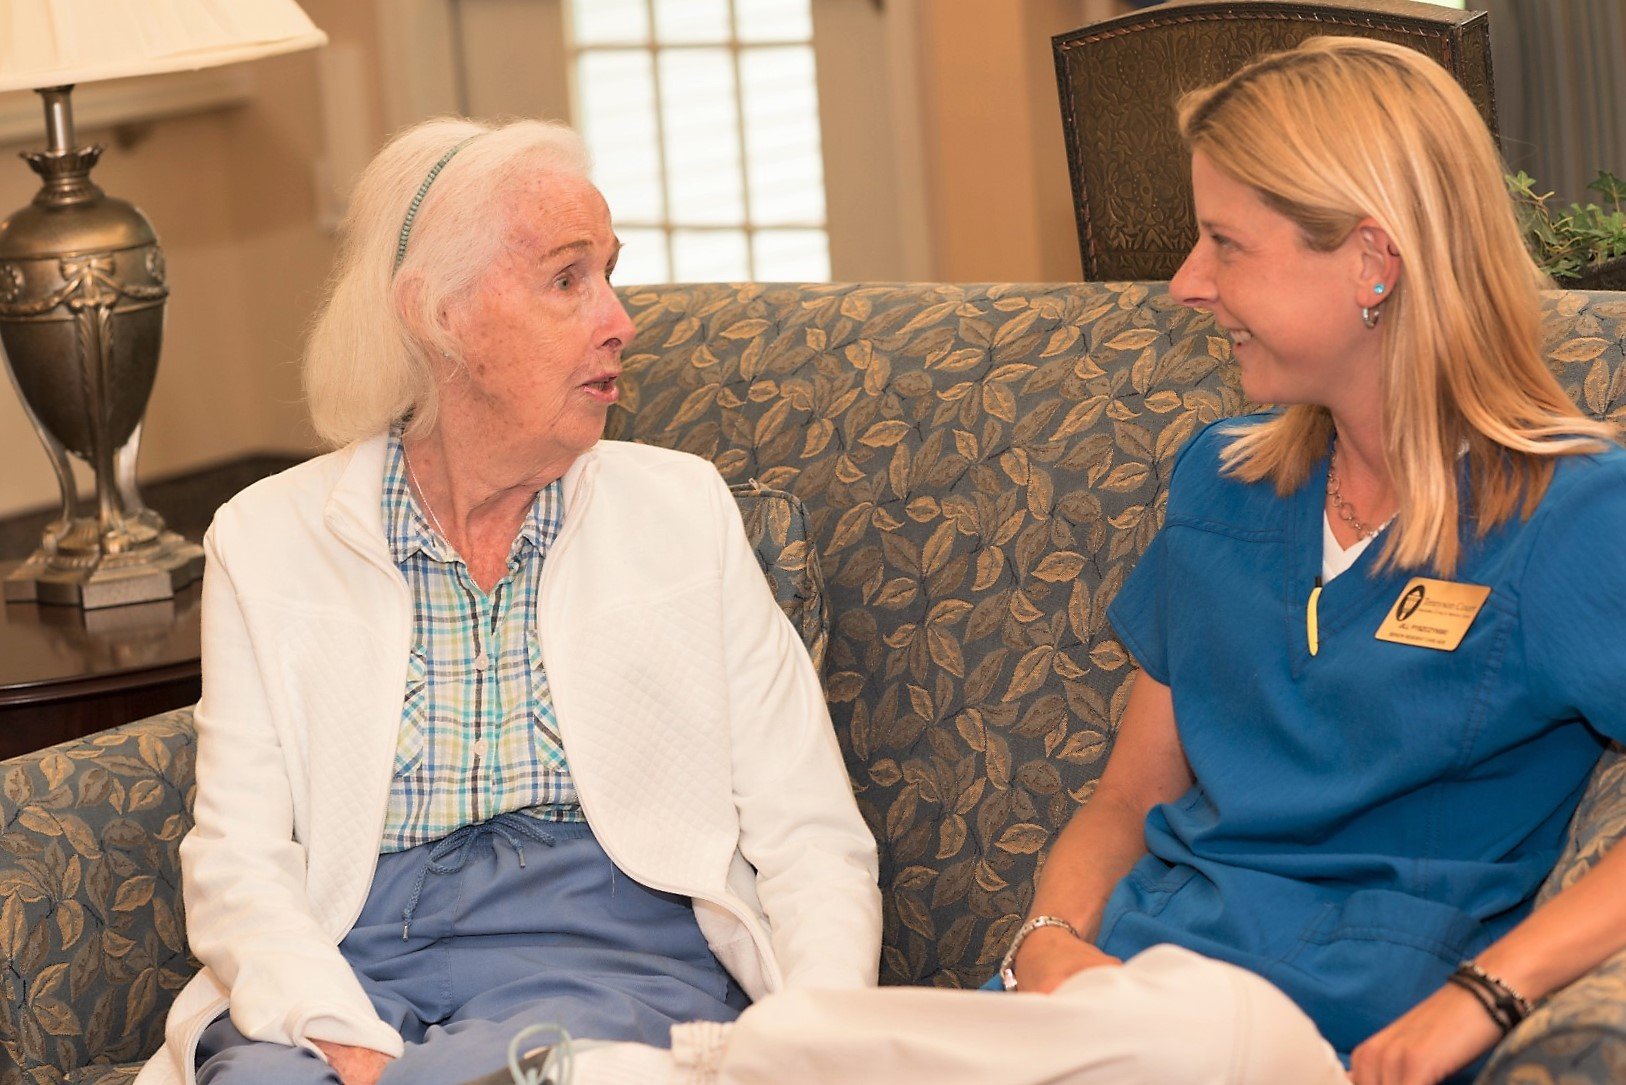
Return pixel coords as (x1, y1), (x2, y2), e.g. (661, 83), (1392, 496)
(3, 532), (203, 610)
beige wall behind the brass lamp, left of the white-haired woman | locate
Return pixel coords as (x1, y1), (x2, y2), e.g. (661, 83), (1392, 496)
(0, 0), (382, 516)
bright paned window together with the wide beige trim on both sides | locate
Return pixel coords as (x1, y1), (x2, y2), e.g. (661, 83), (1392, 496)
(372, 0), (923, 283)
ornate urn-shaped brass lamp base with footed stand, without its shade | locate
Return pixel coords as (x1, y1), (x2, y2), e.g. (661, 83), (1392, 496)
(0, 86), (203, 610)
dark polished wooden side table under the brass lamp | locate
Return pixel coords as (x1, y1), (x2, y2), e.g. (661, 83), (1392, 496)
(0, 563), (202, 760)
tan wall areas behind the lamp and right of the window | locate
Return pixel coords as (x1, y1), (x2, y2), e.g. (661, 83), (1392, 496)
(0, 0), (1119, 516)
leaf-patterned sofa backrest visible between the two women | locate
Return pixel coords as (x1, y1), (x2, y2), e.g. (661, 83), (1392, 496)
(610, 283), (1242, 986)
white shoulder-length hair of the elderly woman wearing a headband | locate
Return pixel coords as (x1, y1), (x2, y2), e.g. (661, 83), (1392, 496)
(304, 117), (589, 446)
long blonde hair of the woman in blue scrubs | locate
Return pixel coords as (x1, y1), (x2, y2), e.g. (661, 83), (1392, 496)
(1179, 37), (1616, 576)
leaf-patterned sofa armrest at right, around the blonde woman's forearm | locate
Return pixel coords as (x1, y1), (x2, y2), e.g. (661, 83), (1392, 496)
(1478, 747), (1626, 1085)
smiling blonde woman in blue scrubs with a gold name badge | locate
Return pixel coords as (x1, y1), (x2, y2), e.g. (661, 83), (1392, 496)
(552, 37), (1626, 1085)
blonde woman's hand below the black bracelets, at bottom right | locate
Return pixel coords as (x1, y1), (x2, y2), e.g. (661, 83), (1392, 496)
(1350, 984), (1501, 1085)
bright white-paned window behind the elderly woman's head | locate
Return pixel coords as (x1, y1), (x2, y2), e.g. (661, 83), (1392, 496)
(567, 0), (829, 283)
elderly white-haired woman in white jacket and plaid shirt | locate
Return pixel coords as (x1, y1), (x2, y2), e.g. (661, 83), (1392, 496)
(141, 120), (880, 1085)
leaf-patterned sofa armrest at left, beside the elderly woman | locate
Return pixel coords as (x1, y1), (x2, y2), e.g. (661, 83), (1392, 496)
(0, 708), (197, 1082)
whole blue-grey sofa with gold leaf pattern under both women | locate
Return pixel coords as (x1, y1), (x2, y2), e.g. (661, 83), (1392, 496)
(9, 283), (1626, 1085)
